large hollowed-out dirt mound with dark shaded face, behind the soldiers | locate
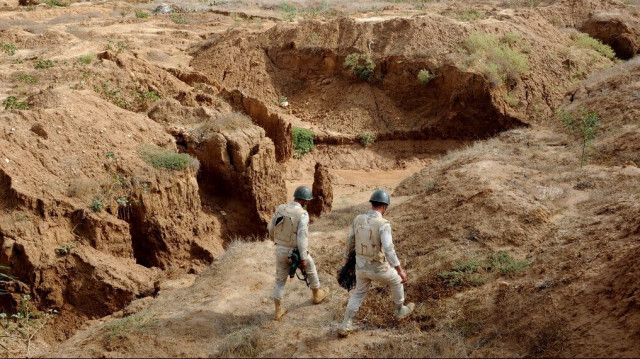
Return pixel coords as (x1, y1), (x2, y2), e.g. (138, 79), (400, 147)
(191, 12), (606, 148)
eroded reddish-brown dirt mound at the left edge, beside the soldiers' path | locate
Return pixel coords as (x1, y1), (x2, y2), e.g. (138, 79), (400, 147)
(0, 89), (222, 337)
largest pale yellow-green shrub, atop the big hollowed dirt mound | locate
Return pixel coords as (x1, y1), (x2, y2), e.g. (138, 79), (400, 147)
(463, 32), (529, 87)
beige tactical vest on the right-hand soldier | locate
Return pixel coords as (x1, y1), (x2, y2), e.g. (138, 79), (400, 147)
(353, 214), (389, 263)
